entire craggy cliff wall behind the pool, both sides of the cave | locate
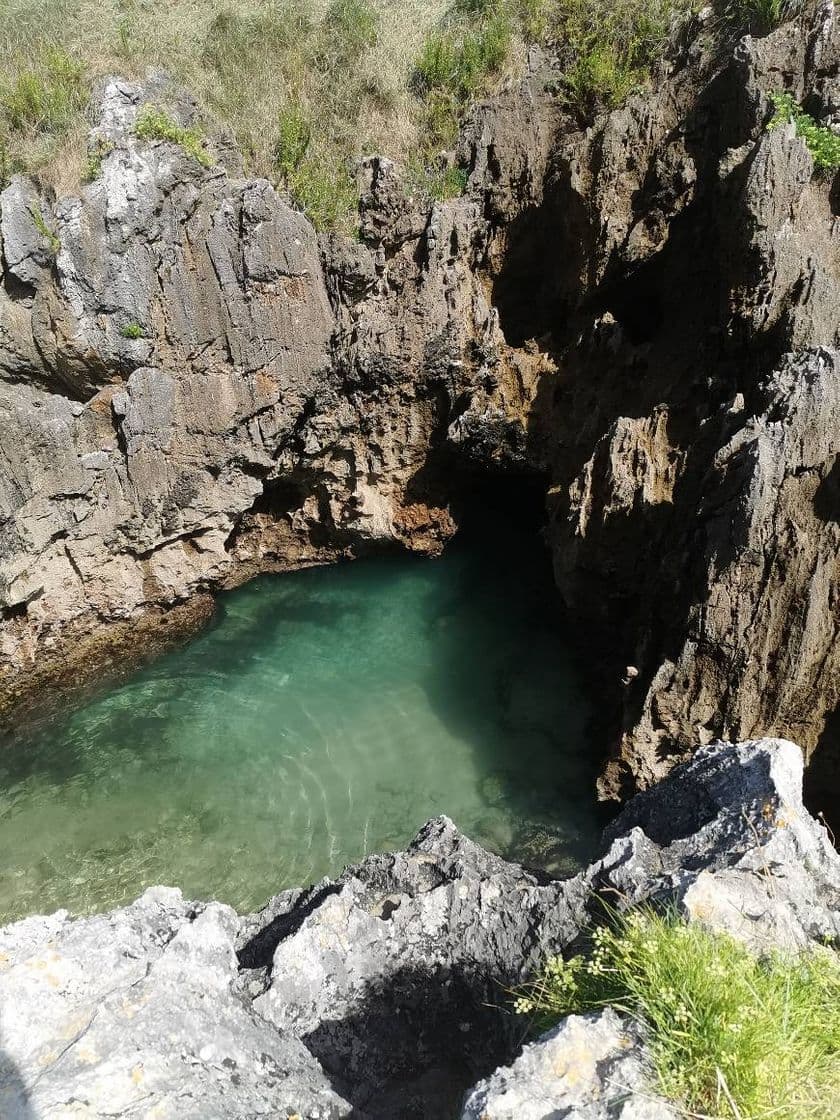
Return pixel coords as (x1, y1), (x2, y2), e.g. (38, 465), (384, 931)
(0, 0), (840, 824)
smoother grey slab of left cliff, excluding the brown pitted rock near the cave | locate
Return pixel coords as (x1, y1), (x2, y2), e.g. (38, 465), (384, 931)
(0, 83), (333, 707)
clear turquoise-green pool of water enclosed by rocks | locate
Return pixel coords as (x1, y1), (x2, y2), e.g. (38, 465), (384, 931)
(0, 529), (597, 920)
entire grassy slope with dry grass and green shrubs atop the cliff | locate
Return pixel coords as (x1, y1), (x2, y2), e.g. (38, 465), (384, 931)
(0, 0), (797, 228)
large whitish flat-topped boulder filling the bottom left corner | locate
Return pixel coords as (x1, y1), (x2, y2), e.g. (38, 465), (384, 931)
(0, 887), (351, 1120)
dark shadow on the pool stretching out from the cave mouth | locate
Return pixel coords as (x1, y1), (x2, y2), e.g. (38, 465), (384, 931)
(423, 478), (598, 875)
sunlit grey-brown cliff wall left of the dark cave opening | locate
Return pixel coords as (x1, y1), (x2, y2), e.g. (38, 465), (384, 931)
(0, 72), (560, 707)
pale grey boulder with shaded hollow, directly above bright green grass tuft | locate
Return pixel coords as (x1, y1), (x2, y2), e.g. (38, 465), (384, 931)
(596, 739), (840, 951)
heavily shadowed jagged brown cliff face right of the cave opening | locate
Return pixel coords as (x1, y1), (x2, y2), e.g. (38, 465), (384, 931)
(492, 3), (840, 810)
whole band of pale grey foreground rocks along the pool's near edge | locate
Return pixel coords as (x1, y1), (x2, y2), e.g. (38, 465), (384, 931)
(0, 740), (840, 1120)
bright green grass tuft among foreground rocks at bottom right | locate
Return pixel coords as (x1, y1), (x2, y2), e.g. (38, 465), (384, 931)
(515, 911), (840, 1120)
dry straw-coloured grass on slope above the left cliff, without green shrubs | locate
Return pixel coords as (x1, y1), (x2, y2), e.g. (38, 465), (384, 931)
(0, 0), (461, 224)
